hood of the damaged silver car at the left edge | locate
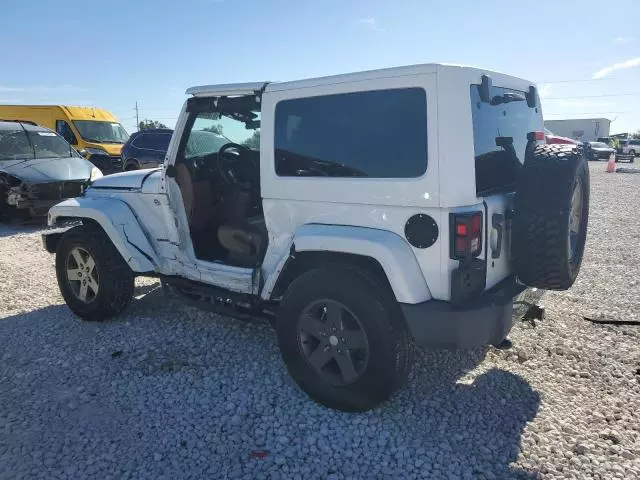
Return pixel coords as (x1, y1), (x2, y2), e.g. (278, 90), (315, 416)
(0, 157), (93, 183)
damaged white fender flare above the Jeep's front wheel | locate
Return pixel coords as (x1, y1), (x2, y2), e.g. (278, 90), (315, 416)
(48, 197), (160, 273)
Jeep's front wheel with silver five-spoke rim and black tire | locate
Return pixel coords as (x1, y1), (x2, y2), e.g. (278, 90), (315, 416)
(56, 224), (135, 321)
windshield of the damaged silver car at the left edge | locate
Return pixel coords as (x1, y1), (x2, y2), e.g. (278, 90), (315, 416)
(0, 125), (78, 161)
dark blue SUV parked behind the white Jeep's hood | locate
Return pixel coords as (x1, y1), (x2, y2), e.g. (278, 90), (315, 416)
(121, 128), (173, 171)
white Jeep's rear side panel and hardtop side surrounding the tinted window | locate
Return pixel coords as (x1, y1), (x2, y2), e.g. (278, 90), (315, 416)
(260, 72), (449, 303)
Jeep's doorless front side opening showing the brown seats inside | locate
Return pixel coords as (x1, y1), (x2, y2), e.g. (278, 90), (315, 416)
(171, 95), (268, 268)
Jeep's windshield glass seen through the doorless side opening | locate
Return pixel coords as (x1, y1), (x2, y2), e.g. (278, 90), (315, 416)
(185, 112), (260, 158)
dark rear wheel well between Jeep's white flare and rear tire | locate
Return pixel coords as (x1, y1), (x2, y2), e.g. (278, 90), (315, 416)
(271, 251), (396, 300)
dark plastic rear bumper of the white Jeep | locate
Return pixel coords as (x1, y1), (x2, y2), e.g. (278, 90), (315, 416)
(400, 277), (526, 349)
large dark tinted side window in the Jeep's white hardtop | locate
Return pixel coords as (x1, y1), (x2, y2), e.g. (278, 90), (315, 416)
(274, 88), (427, 178)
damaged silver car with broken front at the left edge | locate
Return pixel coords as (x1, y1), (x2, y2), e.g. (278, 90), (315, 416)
(0, 121), (102, 220)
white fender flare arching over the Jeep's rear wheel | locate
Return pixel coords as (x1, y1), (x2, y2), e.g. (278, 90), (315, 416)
(262, 224), (431, 303)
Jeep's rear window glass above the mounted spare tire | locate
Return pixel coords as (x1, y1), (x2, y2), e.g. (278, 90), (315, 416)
(471, 85), (544, 197)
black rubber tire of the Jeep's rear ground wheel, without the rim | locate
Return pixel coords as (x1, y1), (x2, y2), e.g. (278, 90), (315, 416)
(276, 265), (413, 412)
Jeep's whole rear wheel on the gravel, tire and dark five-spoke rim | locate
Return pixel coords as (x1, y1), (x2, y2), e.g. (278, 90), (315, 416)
(276, 266), (411, 412)
